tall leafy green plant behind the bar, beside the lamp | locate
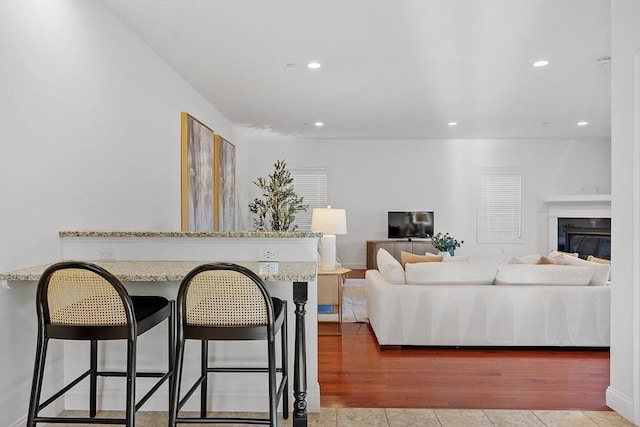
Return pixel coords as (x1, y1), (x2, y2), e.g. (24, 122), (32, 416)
(249, 160), (309, 231)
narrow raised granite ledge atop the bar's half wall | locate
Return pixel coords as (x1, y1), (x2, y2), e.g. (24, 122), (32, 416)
(58, 230), (322, 239)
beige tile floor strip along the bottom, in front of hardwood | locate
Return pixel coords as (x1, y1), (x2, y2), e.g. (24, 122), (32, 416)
(50, 408), (633, 427)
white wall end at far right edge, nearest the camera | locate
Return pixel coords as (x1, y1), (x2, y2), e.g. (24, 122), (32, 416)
(607, 0), (640, 425)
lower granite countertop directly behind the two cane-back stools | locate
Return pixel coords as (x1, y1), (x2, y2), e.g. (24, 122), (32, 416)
(0, 261), (317, 282)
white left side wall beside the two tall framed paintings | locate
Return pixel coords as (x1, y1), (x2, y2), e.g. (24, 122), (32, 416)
(0, 0), (246, 426)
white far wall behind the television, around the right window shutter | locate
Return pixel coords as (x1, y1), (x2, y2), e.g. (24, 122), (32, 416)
(247, 137), (611, 268)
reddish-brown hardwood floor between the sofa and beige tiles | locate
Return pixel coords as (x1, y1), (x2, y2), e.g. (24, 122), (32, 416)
(318, 323), (609, 411)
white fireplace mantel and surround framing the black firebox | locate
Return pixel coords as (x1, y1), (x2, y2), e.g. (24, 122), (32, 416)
(543, 194), (611, 251)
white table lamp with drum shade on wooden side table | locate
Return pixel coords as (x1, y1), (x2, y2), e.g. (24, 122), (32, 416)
(311, 206), (347, 271)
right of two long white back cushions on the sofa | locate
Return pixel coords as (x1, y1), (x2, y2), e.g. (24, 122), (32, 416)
(495, 264), (593, 286)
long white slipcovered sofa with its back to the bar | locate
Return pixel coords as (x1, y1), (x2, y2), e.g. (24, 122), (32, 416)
(365, 250), (610, 347)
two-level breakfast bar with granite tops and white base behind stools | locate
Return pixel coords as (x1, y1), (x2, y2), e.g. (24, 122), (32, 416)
(0, 231), (322, 426)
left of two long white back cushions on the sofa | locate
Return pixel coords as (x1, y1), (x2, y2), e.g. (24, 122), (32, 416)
(405, 262), (498, 285)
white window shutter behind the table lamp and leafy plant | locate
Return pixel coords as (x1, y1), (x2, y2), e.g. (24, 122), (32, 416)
(291, 168), (329, 231)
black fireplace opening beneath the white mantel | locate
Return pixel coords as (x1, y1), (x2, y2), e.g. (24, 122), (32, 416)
(558, 218), (611, 259)
